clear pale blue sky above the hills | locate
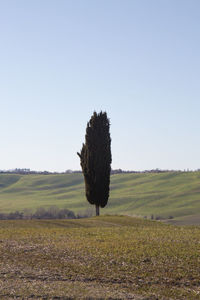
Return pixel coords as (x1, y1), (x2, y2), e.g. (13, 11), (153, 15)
(0, 0), (200, 171)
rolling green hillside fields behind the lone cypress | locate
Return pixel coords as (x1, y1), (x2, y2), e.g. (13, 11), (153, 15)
(0, 172), (200, 218)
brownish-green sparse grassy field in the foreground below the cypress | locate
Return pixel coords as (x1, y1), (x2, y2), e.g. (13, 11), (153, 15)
(0, 216), (200, 300)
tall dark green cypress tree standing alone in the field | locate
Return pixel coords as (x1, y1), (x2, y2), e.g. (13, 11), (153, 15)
(77, 112), (112, 216)
